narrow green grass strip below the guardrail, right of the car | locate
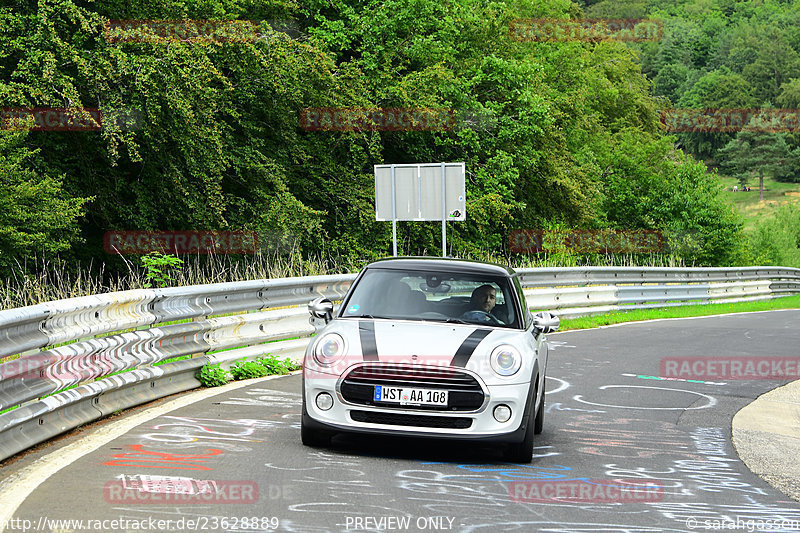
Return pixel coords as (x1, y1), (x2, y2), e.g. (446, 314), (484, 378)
(559, 294), (800, 331)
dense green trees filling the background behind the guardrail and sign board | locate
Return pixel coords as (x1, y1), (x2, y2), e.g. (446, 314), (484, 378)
(0, 0), (768, 282)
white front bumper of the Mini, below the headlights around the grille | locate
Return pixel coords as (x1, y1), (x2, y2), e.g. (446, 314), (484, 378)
(303, 366), (535, 443)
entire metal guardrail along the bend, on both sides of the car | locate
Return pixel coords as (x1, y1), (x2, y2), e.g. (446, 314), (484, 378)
(0, 267), (800, 460)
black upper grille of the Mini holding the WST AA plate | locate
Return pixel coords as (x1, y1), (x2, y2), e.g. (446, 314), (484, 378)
(340, 364), (484, 411)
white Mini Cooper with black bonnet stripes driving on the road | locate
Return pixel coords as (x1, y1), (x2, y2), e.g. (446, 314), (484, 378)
(301, 258), (559, 462)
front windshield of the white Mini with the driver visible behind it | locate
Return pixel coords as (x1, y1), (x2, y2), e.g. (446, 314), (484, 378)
(340, 269), (519, 328)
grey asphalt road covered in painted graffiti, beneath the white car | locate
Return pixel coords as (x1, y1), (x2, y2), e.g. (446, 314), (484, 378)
(0, 311), (800, 532)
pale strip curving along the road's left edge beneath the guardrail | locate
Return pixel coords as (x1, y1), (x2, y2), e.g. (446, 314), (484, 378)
(0, 372), (297, 533)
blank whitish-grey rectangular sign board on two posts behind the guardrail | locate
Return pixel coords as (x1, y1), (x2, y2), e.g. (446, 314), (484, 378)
(375, 163), (467, 221)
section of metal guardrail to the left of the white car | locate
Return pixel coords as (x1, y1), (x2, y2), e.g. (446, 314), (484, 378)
(0, 275), (355, 460)
